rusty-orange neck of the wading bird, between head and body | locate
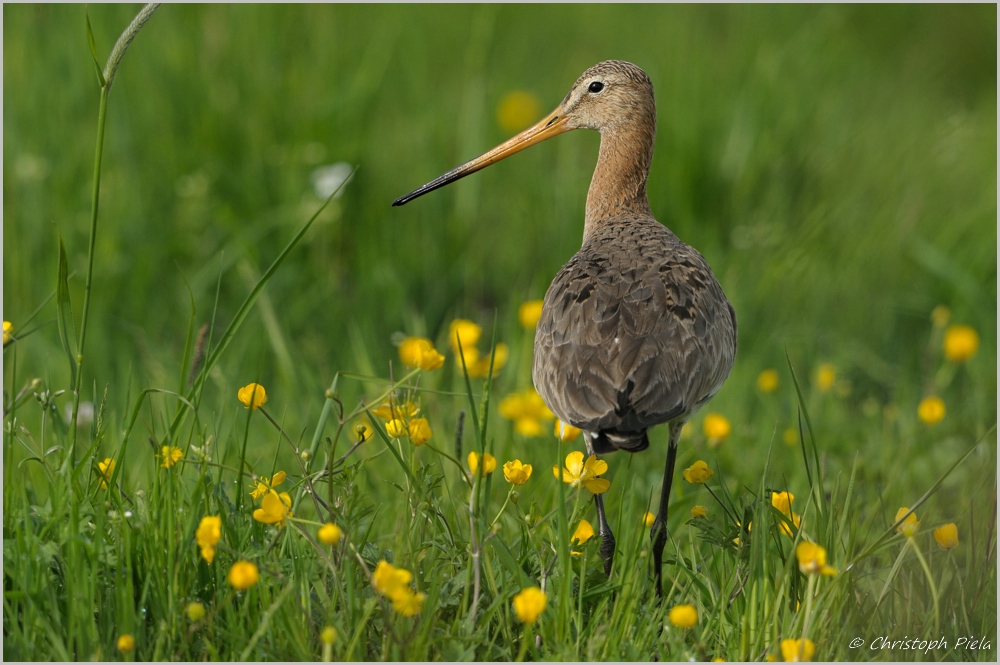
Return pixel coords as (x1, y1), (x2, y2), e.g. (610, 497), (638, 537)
(583, 123), (656, 242)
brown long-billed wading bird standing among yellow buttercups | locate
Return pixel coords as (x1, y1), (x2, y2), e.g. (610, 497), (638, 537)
(392, 60), (737, 598)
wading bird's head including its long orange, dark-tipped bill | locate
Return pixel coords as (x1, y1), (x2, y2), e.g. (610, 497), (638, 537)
(392, 60), (656, 206)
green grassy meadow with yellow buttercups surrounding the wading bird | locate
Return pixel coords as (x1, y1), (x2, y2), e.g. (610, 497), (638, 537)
(3, 5), (997, 661)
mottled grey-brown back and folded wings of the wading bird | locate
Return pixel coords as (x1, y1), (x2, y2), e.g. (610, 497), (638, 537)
(533, 217), (736, 452)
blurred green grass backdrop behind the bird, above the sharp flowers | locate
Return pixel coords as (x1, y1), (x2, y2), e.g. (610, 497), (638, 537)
(3, 5), (997, 486)
